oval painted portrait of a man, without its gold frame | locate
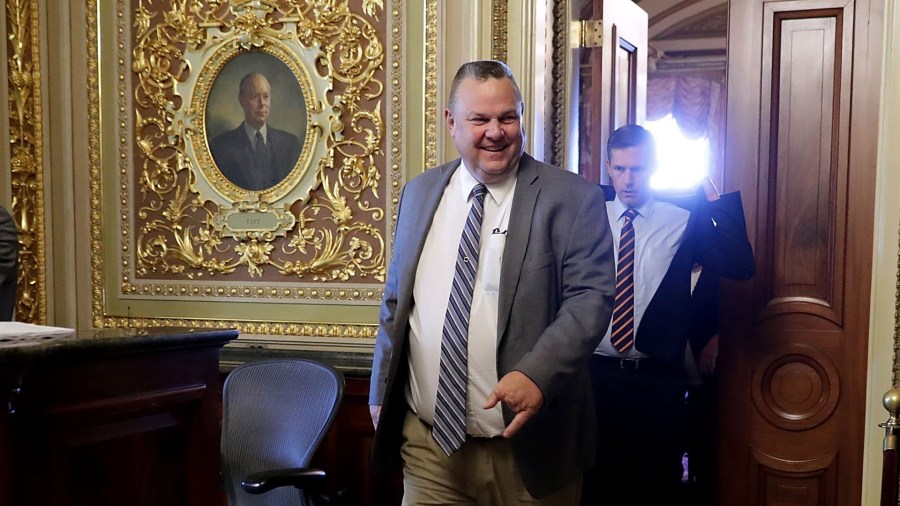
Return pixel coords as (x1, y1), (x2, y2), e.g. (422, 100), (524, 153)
(206, 51), (307, 191)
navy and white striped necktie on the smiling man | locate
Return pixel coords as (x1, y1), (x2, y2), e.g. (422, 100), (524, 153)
(432, 184), (486, 456)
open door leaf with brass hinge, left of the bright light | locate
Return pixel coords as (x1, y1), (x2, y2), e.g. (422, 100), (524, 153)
(578, 0), (648, 183)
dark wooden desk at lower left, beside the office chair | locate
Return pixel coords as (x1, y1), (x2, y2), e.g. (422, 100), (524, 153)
(0, 328), (238, 506)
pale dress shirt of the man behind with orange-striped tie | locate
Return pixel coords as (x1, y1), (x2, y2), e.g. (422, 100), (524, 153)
(595, 197), (691, 358)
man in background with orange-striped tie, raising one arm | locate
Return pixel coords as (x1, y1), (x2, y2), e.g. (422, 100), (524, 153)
(582, 125), (755, 505)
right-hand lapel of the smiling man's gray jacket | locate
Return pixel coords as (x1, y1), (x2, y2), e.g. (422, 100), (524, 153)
(497, 154), (541, 346)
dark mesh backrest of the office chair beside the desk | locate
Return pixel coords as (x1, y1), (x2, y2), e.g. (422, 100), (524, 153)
(221, 359), (344, 506)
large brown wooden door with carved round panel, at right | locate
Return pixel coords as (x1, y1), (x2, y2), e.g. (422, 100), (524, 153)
(719, 0), (884, 506)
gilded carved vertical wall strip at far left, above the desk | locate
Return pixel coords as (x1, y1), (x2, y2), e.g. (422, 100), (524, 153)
(6, 0), (47, 323)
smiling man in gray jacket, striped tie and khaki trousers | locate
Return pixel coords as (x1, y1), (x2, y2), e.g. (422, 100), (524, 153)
(369, 61), (615, 505)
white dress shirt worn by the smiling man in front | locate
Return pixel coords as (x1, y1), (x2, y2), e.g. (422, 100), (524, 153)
(406, 162), (518, 437)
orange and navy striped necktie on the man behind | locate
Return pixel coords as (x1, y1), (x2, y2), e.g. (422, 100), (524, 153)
(610, 209), (637, 353)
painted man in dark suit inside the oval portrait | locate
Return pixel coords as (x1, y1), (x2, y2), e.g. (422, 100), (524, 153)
(209, 72), (301, 191)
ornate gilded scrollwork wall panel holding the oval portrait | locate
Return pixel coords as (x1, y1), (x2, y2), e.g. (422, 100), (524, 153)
(88, 0), (434, 337)
